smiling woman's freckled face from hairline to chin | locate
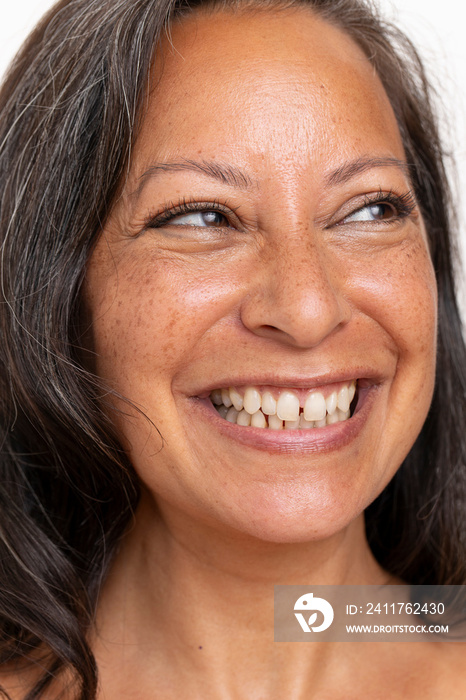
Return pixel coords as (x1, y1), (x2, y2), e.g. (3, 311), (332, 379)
(86, 9), (436, 542)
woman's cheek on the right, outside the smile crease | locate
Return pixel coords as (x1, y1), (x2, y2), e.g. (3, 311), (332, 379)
(355, 241), (437, 465)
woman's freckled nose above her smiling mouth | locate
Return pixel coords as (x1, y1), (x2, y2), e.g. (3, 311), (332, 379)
(241, 235), (352, 348)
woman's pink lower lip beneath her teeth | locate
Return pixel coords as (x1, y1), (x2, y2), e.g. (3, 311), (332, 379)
(189, 385), (380, 453)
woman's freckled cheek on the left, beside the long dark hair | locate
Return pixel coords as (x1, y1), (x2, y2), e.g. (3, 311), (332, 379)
(86, 246), (244, 388)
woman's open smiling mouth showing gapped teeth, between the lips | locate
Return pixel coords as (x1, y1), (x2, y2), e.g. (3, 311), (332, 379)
(210, 379), (357, 430)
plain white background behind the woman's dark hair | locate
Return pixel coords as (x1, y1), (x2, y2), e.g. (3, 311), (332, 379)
(0, 0), (466, 300)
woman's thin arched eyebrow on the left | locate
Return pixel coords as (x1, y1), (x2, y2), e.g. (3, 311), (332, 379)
(131, 158), (255, 197)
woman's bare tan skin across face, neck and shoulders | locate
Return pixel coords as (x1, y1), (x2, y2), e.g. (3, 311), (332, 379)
(63, 9), (464, 700)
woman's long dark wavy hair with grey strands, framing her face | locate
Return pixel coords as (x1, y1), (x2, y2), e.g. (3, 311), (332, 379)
(0, 0), (466, 700)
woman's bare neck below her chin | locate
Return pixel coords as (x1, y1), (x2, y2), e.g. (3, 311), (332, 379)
(96, 492), (388, 698)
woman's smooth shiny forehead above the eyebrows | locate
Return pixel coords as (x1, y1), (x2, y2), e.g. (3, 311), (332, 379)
(128, 8), (403, 185)
